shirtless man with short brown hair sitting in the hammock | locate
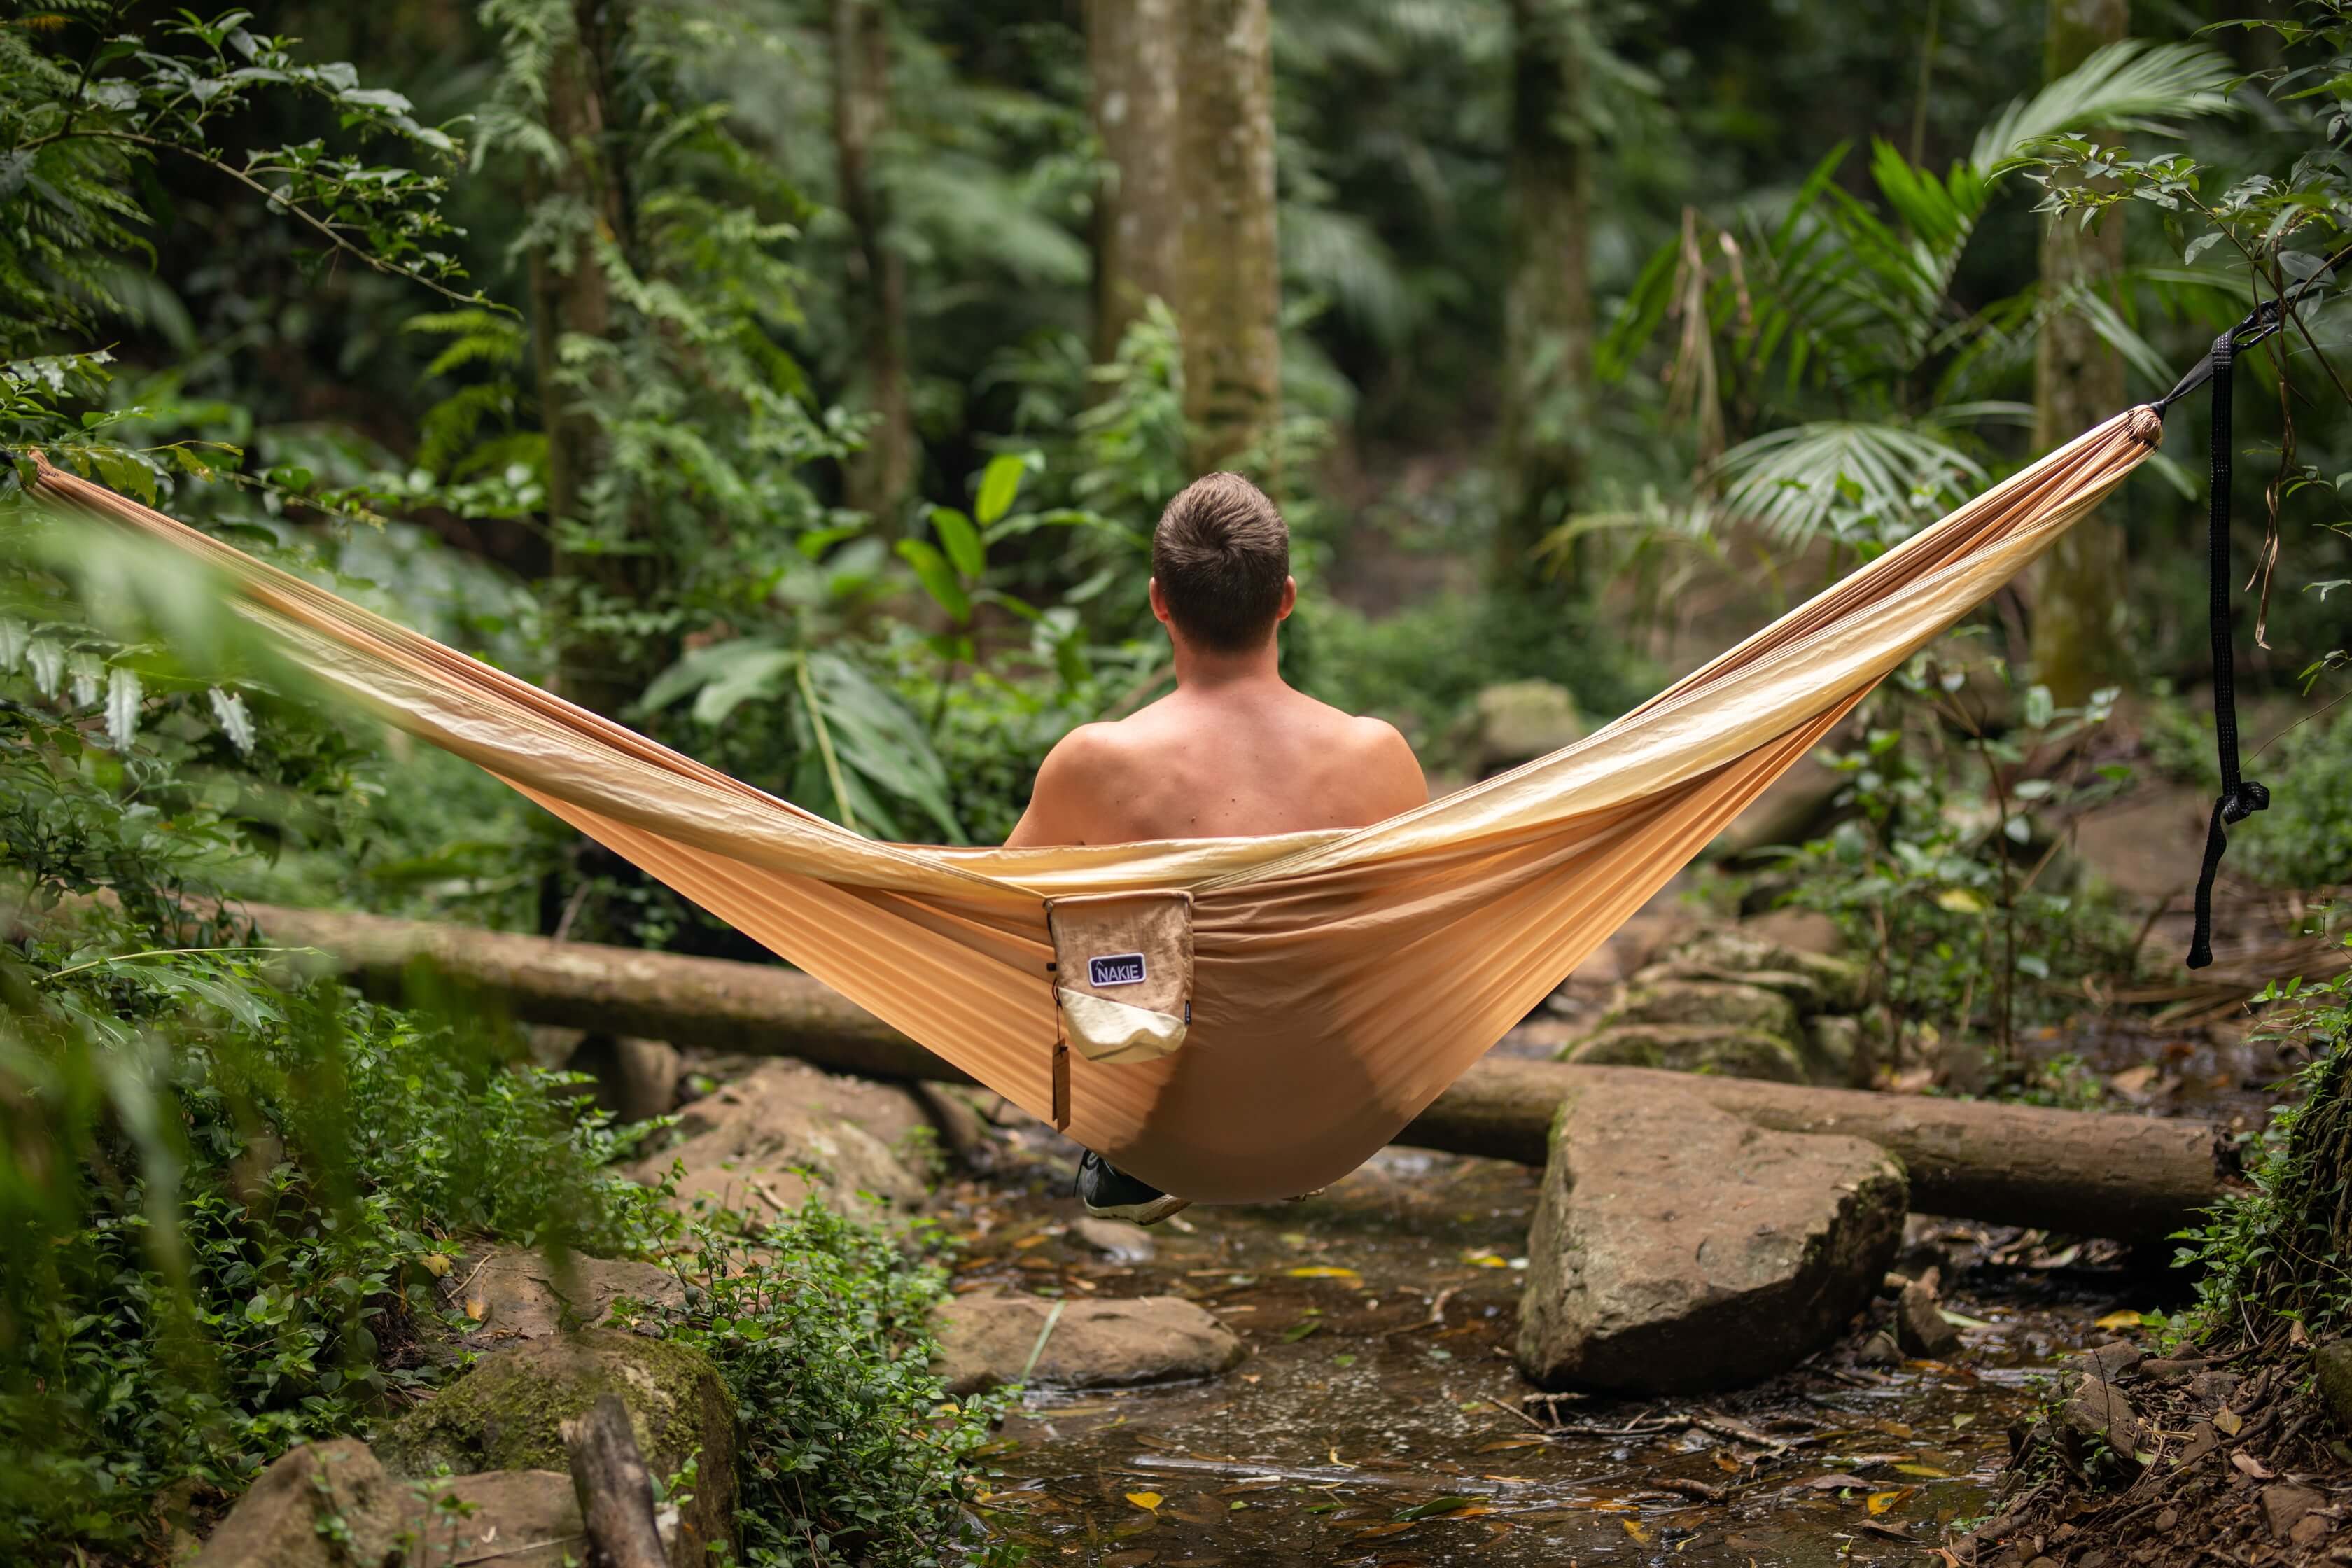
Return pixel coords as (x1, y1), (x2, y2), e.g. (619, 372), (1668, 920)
(1007, 472), (1430, 1225)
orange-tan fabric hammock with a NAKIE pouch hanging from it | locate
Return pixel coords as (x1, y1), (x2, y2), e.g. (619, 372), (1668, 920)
(22, 407), (2164, 1201)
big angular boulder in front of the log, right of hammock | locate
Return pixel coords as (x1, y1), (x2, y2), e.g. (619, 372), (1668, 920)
(1520, 1086), (1907, 1394)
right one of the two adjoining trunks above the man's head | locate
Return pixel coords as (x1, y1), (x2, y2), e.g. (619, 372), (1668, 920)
(1176, 0), (1282, 472)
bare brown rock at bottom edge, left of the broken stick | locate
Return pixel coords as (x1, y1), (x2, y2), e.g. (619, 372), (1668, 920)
(195, 1438), (586, 1568)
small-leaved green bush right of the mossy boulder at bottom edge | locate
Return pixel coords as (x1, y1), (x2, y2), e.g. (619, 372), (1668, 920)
(671, 1199), (1018, 1568)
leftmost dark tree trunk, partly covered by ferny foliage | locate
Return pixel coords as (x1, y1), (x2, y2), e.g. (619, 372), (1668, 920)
(524, 0), (642, 715)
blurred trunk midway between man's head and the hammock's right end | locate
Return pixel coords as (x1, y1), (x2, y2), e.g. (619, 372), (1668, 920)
(1496, 0), (1592, 583)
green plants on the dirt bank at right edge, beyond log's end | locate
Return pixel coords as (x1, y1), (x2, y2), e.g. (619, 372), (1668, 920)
(2176, 938), (2352, 1350)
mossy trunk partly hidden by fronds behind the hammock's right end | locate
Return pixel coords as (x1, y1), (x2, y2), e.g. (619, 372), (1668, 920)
(2032, 0), (2131, 703)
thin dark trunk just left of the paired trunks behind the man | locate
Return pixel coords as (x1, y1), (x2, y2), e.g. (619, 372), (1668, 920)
(832, 0), (915, 519)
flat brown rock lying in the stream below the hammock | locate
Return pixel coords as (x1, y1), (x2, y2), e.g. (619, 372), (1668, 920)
(934, 1293), (1244, 1394)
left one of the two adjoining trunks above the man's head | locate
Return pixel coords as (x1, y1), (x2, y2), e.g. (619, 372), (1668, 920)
(1086, 0), (1183, 362)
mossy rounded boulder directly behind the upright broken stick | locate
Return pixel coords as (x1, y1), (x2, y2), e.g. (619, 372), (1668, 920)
(377, 1328), (736, 1568)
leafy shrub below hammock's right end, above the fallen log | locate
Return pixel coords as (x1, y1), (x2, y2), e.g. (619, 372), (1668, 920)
(1773, 656), (2131, 1067)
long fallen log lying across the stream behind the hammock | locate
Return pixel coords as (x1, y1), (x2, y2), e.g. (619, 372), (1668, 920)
(247, 905), (2222, 1241)
